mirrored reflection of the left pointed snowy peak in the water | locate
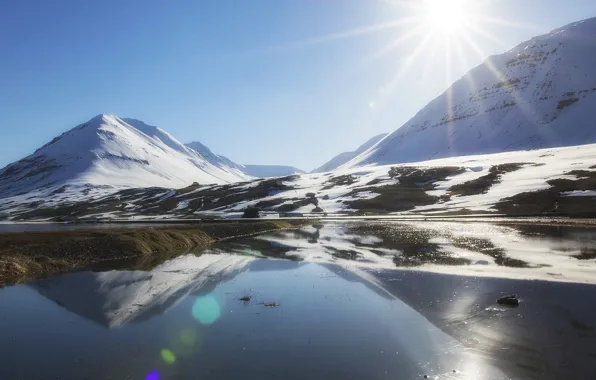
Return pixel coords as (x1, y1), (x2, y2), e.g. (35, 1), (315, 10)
(29, 254), (252, 327)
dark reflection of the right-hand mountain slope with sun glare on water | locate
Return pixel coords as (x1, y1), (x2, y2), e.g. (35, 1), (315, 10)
(316, 252), (596, 380)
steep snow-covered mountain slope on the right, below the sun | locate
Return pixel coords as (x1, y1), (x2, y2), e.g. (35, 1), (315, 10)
(345, 18), (596, 168)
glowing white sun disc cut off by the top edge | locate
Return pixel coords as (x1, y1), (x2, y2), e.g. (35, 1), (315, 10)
(422, 0), (471, 35)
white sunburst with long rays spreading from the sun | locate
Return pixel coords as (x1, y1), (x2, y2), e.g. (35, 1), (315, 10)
(260, 0), (538, 113)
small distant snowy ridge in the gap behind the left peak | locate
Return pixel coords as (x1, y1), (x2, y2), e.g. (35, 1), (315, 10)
(186, 141), (305, 178)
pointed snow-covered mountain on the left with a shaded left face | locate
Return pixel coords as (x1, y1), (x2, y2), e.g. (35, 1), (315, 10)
(0, 114), (249, 196)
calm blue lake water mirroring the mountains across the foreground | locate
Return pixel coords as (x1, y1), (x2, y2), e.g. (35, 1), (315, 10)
(0, 223), (596, 380)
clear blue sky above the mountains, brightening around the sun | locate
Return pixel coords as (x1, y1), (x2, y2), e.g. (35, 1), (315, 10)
(0, 0), (596, 170)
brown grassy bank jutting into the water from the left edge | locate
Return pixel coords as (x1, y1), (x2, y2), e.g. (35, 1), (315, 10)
(0, 219), (313, 287)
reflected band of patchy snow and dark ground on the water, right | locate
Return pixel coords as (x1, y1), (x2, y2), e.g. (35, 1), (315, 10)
(235, 221), (596, 283)
